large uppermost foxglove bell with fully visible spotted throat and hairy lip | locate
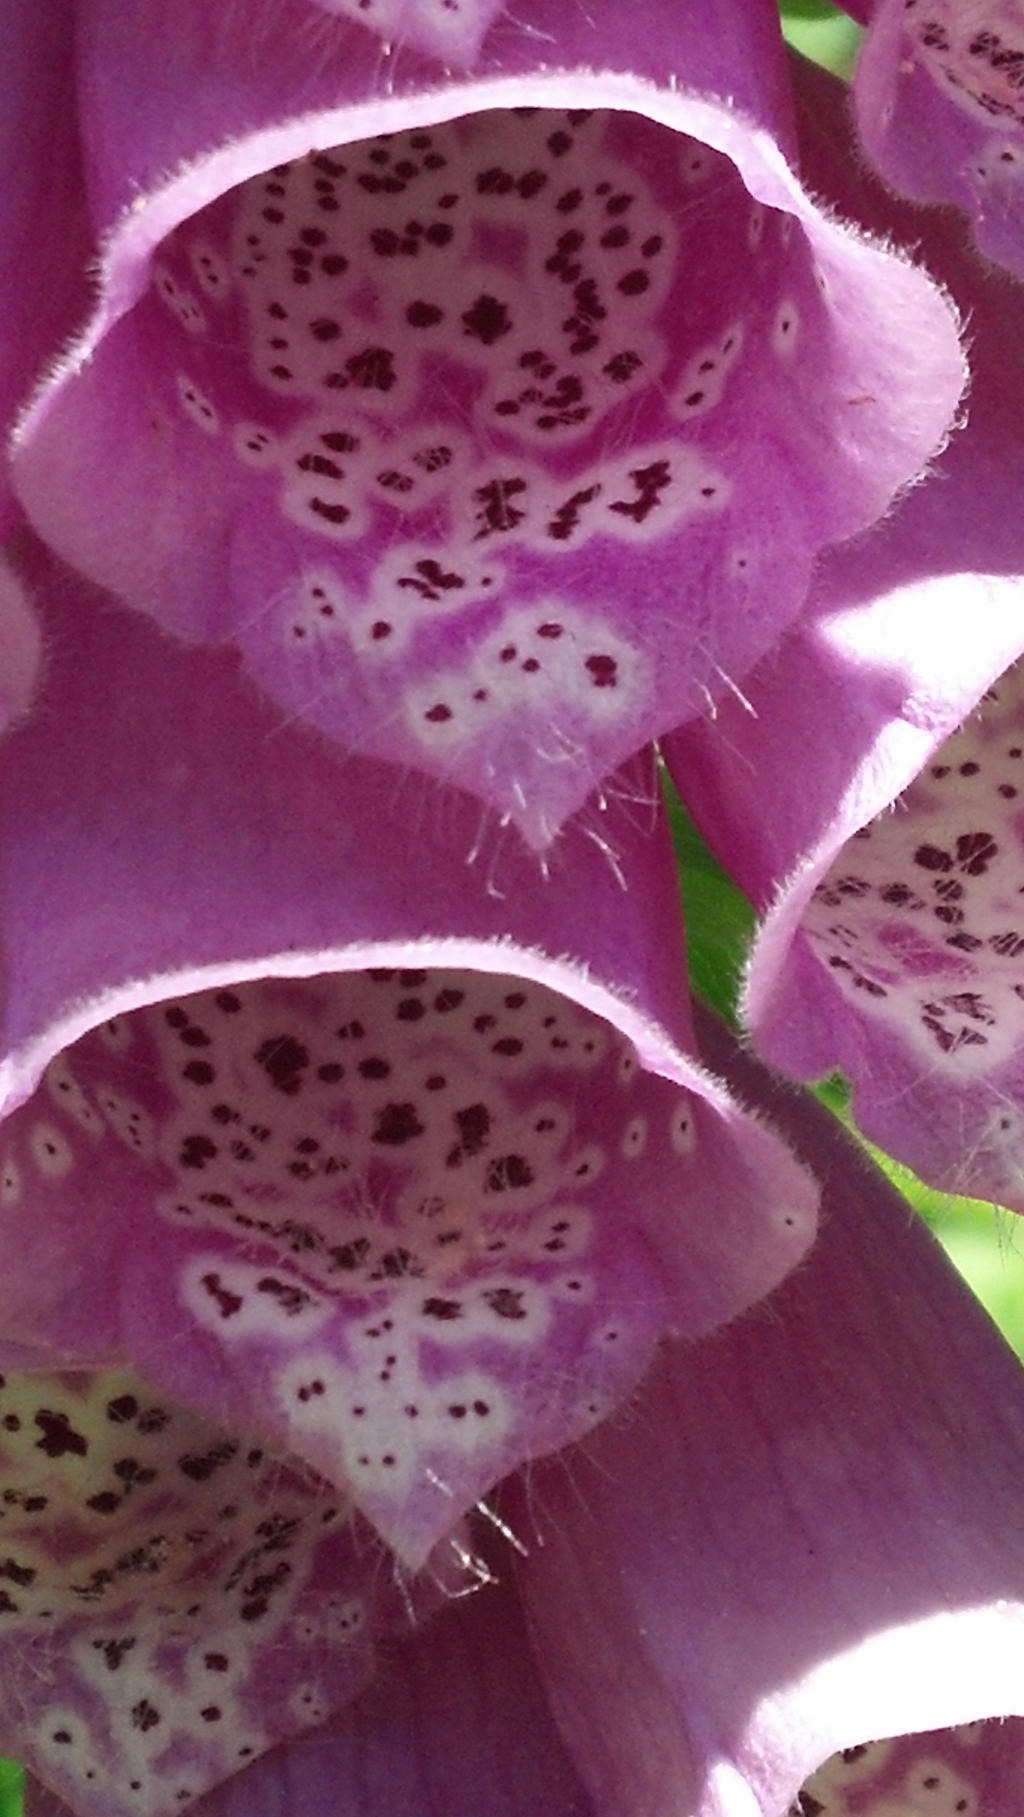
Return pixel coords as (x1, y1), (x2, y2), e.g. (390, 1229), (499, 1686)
(7, 0), (962, 849)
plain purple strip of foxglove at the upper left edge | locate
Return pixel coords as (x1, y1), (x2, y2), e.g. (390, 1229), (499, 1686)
(0, 0), (93, 537)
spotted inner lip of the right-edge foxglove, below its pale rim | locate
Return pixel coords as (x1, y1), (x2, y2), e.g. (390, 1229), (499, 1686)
(784, 663), (1024, 1210)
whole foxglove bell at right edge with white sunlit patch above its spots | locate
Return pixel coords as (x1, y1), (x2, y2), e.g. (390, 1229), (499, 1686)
(666, 60), (1024, 1206)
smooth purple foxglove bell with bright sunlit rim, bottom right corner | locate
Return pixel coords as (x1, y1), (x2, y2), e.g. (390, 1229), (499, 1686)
(508, 1010), (1024, 1817)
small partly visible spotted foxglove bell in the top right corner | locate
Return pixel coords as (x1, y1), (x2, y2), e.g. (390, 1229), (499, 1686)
(844, 0), (1024, 276)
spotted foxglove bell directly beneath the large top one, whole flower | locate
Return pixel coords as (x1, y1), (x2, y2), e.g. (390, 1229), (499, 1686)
(0, 545), (815, 1566)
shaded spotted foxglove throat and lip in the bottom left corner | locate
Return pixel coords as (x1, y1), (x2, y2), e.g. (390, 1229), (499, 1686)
(0, 1372), (396, 1817)
